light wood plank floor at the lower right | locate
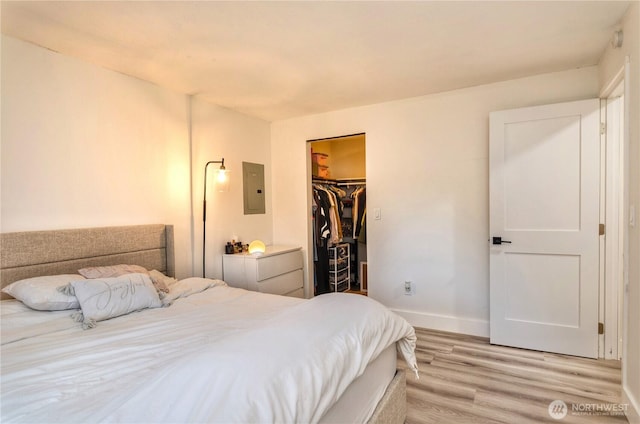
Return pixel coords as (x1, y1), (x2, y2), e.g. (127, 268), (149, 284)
(398, 328), (627, 424)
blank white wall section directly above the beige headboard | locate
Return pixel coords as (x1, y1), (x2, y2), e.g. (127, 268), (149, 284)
(0, 36), (191, 275)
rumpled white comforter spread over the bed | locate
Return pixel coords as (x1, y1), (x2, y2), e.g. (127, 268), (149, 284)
(0, 279), (417, 423)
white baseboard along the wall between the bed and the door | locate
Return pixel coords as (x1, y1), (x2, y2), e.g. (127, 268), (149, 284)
(393, 309), (489, 337)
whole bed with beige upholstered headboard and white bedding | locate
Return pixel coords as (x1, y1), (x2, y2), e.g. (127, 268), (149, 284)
(0, 225), (417, 423)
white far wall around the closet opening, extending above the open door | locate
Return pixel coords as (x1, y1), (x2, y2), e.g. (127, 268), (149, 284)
(271, 67), (598, 335)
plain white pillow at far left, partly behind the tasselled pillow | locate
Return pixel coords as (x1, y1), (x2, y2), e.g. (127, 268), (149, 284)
(2, 274), (84, 311)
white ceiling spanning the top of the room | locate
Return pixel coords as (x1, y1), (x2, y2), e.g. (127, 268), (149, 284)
(1, 0), (631, 121)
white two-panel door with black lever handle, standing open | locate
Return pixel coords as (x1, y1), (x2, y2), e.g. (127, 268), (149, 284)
(489, 99), (600, 358)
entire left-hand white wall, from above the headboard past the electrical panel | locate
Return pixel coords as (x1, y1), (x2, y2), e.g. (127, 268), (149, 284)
(0, 36), (272, 277)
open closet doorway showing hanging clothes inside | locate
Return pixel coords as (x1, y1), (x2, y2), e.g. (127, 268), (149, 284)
(308, 133), (367, 296)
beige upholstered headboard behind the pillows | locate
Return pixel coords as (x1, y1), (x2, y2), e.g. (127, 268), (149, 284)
(0, 224), (175, 299)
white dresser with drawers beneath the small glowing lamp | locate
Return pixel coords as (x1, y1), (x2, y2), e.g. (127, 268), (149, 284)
(222, 246), (304, 298)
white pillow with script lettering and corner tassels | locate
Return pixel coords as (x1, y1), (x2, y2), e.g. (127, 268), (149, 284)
(70, 274), (162, 329)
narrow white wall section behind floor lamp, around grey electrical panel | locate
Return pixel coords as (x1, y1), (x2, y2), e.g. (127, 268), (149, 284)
(192, 98), (273, 278)
